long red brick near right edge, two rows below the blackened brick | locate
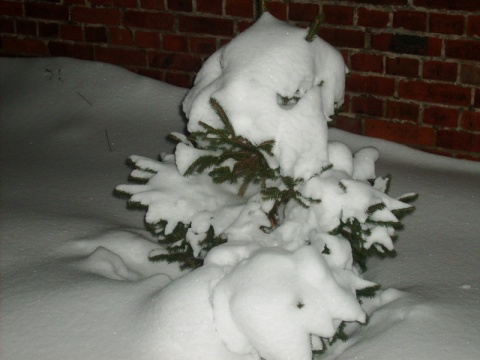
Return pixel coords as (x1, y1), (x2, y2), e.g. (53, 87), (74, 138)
(398, 81), (470, 106)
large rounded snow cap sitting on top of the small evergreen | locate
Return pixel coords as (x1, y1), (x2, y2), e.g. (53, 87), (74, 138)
(183, 13), (348, 179)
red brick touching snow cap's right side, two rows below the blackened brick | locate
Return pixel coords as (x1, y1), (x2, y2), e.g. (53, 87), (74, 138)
(346, 73), (395, 96)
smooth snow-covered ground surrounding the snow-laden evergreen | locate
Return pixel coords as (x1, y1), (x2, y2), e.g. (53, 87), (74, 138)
(0, 58), (480, 360)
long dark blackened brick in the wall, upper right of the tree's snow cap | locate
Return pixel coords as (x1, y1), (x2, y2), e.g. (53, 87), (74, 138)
(370, 33), (442, 56)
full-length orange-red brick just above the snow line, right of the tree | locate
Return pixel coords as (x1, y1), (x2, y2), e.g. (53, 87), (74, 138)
(365, 119), (435, 146)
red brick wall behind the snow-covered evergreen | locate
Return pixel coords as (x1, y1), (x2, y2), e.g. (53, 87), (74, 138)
(0, 0), (480, 160)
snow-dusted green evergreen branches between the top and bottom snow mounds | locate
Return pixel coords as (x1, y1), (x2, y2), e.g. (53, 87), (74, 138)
(116, 7), (417, 358)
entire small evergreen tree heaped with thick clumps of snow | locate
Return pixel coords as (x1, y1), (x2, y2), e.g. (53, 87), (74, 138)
(116, 13), (415, 360)
